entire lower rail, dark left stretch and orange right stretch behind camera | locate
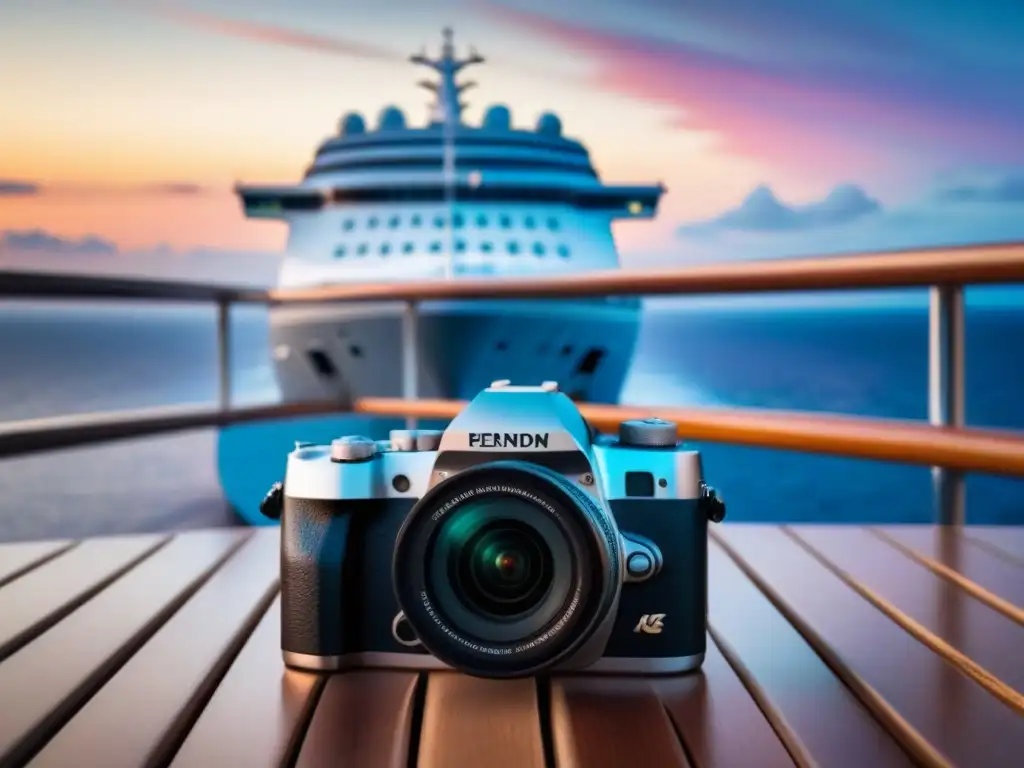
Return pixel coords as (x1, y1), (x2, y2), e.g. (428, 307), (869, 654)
(0, 397), (1024, 476)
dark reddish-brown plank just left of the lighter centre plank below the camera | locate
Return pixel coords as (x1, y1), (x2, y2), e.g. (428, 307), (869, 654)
(296, 670), (419, 768)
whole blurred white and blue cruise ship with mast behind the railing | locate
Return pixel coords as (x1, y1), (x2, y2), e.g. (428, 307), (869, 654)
(237, 29), (665, 402)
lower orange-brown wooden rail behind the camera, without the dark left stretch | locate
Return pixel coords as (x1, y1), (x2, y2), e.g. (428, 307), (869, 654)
(353, 397), (1024, 476)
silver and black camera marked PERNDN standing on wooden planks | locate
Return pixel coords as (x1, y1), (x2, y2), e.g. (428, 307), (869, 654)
(263, 381), (725, 678)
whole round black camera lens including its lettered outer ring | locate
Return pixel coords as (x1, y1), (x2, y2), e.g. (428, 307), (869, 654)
(392, 462), (620, 677)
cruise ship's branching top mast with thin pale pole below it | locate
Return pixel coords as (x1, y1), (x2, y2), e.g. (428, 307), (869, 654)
(410, 27), (483, 279)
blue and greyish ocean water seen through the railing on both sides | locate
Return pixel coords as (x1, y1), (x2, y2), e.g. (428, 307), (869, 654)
(0, 303), (1024, 541)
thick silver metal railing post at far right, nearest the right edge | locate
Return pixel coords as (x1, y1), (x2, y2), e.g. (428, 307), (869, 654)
(928, 286), (967, 525)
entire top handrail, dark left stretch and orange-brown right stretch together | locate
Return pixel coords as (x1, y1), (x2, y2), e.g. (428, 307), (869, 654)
(0, 243), (1024, 304)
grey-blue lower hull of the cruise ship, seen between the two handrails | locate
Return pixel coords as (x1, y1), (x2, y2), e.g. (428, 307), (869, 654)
(270, 299), (640, 402)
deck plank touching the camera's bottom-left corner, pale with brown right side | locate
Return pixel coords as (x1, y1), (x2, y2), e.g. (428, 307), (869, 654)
(171, 597), (326, 768)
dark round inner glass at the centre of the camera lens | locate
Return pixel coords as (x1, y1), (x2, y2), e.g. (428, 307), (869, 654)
(449, 518), (554, 618)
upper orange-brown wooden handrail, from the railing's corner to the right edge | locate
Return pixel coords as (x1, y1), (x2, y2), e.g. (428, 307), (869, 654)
(269, 243), (1024, 304)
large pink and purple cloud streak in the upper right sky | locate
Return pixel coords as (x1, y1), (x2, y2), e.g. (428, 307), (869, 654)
(493, 8), (1013, 177)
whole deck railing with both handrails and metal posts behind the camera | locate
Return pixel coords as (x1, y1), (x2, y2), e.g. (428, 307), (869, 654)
(0, 243), (1024, 524)
